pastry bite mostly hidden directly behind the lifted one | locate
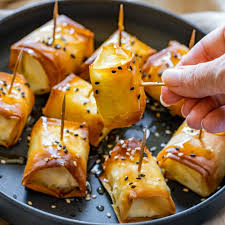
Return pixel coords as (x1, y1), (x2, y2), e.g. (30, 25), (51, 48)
(78, 31), (156, 80)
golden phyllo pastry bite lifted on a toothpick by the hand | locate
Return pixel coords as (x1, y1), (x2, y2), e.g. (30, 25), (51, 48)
(90, 44), (146, 129)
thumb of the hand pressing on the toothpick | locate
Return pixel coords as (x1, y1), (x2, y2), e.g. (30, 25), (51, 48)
(162, 54), (225, 98)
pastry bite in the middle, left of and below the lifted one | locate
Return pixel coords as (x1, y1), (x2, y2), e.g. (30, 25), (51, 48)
(43, 74), (110, 146)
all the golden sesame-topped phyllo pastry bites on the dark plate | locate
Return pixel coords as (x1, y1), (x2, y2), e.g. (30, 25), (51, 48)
(0, 1), (225, 223)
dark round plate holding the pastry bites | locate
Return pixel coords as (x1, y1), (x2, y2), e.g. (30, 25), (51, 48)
(0, 0), (225, 225)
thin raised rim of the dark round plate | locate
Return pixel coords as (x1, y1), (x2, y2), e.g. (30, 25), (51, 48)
(0, 0), (225, 225)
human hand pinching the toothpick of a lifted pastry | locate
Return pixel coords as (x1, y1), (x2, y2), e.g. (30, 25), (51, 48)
(161, 26), (225, 133)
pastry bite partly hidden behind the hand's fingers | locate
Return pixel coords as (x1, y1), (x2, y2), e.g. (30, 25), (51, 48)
(142, 41), (189, 116)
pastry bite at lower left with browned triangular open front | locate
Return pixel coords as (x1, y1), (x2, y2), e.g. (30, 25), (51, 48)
(22, 117), (89, 198)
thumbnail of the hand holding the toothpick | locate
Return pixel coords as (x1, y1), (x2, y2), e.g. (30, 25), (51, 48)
(162, 69), (182, 87)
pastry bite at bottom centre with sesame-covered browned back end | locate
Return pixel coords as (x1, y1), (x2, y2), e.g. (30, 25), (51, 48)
(100, 138), (176, 223)
